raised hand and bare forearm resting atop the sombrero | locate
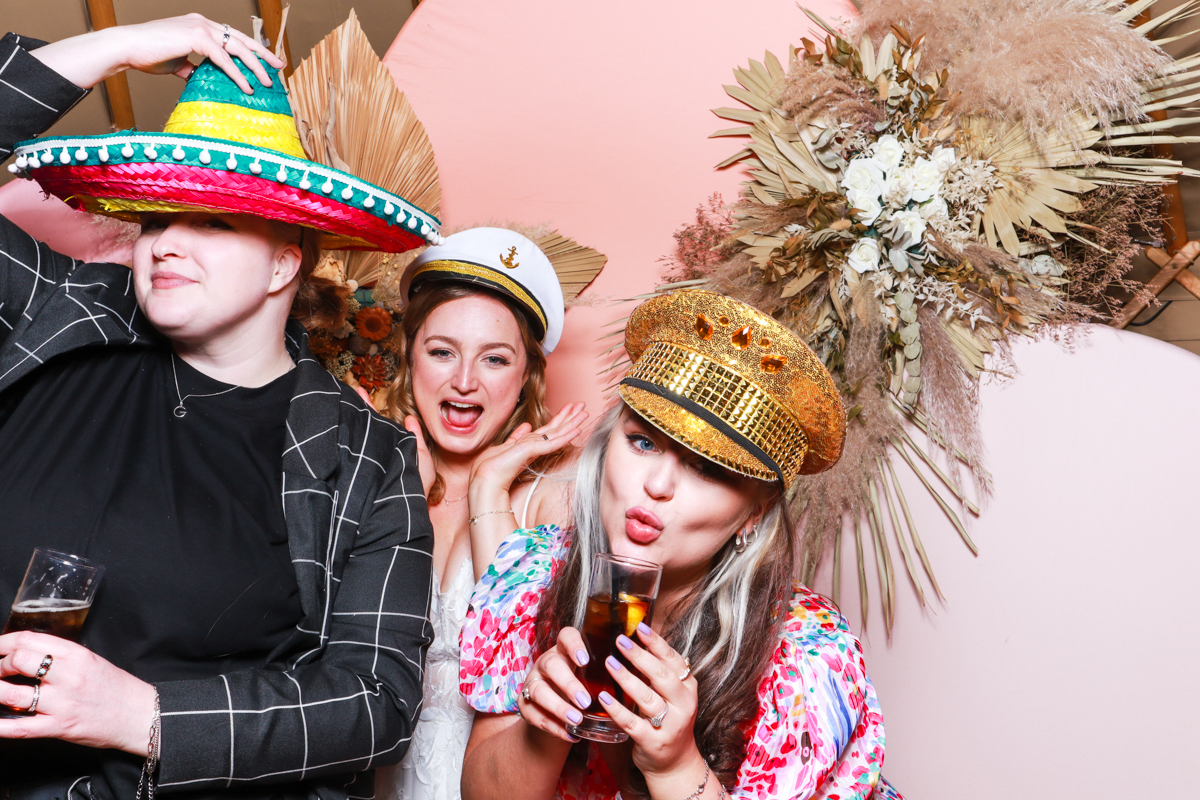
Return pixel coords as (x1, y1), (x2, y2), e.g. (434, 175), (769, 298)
(32, 14), (283, 94)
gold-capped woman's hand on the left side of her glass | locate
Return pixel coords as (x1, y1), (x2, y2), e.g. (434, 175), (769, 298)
(517, 627), (592, 742)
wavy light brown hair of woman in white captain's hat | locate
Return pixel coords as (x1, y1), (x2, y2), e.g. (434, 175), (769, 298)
(383, 281), (563, 505)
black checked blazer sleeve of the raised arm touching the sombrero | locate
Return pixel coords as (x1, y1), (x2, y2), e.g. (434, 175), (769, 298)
(0, 34), (88, 344)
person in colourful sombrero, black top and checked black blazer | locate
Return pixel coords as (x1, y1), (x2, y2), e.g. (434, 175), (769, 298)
(0, 16), (440, 800)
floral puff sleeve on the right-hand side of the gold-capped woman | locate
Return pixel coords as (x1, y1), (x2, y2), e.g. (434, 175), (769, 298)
(731, 585), (900, 800)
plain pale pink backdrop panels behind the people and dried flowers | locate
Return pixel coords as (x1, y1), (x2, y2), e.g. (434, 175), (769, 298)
(0, 0), (1200, 800)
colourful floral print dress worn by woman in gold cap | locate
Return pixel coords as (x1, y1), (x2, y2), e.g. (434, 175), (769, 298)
(460, 525), (900, 800)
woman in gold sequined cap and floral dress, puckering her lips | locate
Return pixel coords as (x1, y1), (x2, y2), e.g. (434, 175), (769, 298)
(461, 290), (898, 800)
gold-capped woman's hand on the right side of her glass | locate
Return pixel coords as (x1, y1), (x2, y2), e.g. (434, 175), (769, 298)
(600, 622), (702, 794)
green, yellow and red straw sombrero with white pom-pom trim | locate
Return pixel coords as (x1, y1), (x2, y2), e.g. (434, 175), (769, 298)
(12, 59), (442, 253)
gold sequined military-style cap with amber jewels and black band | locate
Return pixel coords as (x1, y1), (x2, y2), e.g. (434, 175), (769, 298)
(619, 289), (846, 486)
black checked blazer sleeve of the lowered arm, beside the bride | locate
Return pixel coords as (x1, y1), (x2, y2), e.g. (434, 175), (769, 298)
(157, 434), (433, 793)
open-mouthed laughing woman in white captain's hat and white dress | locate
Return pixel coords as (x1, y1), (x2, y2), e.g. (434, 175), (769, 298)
(377, 227), (587, 800)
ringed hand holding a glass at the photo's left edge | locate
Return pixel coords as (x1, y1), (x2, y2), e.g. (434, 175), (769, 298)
(0, 631), (155, 757)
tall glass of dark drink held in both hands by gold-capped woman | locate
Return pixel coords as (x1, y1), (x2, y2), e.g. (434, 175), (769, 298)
(566, 553), (662, 742)
